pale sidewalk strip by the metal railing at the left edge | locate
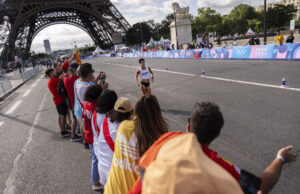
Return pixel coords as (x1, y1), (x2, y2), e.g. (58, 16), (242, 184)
(0, 66), (42, 101)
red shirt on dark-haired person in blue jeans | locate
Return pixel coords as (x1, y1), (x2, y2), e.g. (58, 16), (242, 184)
(83, 101), (97, 145)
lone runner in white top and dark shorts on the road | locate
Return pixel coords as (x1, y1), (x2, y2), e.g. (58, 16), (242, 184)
(135, 59), (154, 96)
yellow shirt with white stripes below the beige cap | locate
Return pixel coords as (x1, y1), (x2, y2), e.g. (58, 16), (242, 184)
(104, 121), (140, 194)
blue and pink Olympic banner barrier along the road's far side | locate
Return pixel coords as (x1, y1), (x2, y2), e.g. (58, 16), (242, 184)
(123, 43), (300, 60)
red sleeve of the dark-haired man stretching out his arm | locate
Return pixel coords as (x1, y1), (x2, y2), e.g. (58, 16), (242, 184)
(202, 146), (240, 181)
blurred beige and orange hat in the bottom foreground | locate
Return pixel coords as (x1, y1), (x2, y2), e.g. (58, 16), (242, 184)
(141, 132), (244, 194)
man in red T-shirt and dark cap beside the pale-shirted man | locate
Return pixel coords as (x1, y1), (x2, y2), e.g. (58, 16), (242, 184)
(64, 63), (82, 142)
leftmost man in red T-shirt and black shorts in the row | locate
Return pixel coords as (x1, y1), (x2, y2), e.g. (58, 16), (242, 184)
(45, 69), (70, 137)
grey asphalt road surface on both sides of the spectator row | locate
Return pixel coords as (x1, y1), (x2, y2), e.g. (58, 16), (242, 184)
(0, 58), (300, 194)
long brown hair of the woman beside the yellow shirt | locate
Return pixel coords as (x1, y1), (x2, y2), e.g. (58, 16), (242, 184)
(134, 95), (168, 156)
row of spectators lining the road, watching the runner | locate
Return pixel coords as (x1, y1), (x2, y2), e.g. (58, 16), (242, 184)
(45, 58), (296, 194)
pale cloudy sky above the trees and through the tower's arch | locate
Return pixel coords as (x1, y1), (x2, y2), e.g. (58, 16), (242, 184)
(31, 0), (279, 52)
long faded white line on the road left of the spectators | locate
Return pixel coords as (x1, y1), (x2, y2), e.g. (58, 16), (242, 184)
(3, 94), (47, 194)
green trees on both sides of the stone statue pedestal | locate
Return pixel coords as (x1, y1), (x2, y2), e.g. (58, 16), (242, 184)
(126, 4), (300, 45)
